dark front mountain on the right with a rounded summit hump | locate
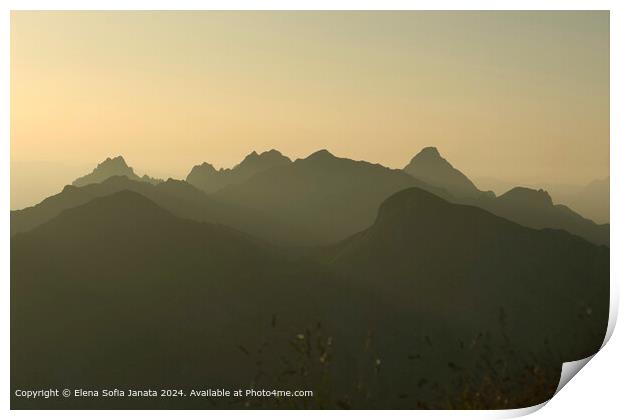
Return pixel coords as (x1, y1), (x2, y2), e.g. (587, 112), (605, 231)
(326, 188), (609, 360)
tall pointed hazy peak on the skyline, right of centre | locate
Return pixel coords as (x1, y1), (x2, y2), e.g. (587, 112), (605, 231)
(403, 147), (494, 200)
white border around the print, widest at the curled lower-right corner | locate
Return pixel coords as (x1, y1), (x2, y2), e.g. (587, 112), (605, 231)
(0, 0), (620, 420)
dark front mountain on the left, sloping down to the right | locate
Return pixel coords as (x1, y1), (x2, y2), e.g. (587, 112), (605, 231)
(11, 191), (370, 408)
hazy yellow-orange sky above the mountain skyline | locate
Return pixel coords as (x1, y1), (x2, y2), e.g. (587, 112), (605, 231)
(11, 12), (609, 184)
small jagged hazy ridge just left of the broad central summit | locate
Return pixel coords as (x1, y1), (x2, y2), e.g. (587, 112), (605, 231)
(186, 149), (291, 193)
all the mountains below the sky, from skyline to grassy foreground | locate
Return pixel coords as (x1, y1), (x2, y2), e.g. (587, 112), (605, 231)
(11, 147), (610, 409)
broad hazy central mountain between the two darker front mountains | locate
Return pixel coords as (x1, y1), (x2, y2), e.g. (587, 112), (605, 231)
(214, 150), (446, 244)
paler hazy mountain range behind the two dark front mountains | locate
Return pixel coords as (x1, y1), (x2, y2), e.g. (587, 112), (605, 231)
(11, 147), (609, 245)
